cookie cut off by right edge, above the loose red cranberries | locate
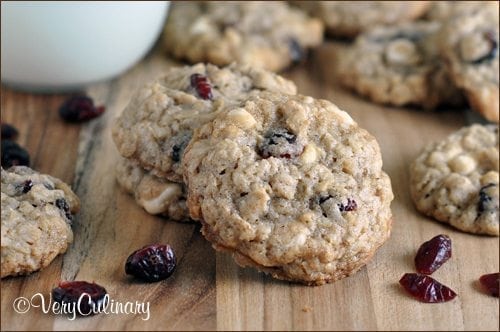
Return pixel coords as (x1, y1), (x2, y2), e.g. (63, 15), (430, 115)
(410, 125), (499, 236)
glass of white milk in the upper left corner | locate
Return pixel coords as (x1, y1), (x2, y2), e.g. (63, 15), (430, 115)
(1, 1), (169, 92)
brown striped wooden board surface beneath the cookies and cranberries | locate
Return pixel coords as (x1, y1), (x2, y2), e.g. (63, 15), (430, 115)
(1, 43), (499, 331)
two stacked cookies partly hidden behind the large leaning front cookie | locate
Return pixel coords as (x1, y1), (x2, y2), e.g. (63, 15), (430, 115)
(113, 64), (297, 221)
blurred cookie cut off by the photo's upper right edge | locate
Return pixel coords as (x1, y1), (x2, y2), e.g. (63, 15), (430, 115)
(440, 6), (499, 122)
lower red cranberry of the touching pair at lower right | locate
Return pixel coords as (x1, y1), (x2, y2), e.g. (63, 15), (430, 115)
(399, 273), (457, 303)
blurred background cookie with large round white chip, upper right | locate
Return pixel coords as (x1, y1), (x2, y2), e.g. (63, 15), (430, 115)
(338, 22), (462, 109)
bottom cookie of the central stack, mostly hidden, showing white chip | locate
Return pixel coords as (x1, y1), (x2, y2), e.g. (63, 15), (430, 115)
(116, 158), (190, 221)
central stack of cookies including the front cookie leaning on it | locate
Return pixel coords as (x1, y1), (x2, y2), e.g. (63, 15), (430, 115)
(113, 64), (393, 285)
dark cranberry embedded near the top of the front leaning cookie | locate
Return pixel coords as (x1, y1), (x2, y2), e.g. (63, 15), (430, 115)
(259, 129), (303, 158)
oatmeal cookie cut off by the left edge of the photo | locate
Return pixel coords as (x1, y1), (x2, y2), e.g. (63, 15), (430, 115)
(1, 166), (80, 278)
